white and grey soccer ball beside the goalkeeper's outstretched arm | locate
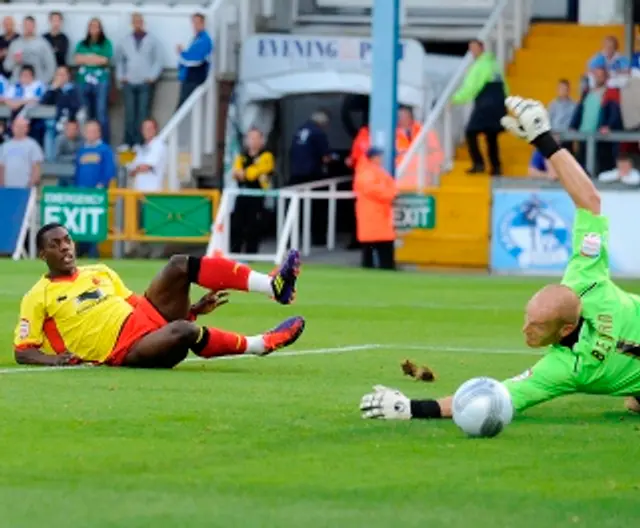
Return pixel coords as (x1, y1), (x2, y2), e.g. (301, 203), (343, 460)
(453, 378), (513, 438)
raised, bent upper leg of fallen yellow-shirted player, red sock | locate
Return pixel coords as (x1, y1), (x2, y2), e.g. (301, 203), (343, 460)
(145, 250), (300, 321)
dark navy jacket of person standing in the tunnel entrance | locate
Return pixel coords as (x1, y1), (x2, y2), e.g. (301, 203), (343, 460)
(289, 121), (329, 180)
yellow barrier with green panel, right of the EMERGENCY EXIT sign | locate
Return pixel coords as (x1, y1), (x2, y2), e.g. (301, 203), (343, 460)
(108, 188), (220, 243)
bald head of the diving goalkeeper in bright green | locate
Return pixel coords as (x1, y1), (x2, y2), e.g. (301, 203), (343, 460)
(522, 284), (581, 348)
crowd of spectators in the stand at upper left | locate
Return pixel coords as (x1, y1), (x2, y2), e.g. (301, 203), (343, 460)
(0, 12), (213, 191)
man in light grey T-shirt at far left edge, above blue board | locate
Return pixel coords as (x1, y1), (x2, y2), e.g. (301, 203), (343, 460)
(0, 117), (44, 189)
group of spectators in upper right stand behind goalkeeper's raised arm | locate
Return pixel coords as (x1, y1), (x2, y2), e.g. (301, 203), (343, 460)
(529, 36), (640, 186)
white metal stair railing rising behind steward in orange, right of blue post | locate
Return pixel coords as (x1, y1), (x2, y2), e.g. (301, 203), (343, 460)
(396, 0), (531, 190)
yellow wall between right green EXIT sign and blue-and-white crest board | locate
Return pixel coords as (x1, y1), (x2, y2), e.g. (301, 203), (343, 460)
(396, 183), (491, 268)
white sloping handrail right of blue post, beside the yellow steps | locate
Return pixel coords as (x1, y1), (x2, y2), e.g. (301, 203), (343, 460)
(396, 0), (531, 190)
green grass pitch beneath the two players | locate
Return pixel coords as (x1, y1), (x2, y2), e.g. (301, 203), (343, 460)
(0, 261), (640, 528)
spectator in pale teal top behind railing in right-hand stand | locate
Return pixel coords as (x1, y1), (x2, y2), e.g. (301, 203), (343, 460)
(569, 63), (614, 170)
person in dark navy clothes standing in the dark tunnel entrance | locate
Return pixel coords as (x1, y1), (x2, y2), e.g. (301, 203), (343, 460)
(289, 110), (331, 246)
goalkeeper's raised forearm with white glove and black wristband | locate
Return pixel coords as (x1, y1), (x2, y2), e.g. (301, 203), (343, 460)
(502, 96), (600, 214)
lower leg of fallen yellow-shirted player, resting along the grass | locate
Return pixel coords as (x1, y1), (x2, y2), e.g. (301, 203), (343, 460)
(121, 317), (305, 368)
